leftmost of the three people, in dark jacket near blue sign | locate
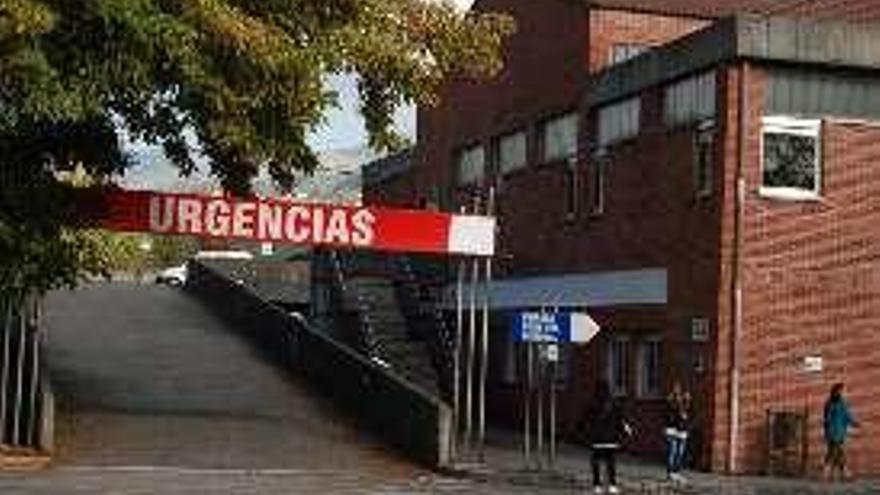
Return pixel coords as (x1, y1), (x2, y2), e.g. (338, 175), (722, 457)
(584, 381), (632, 493)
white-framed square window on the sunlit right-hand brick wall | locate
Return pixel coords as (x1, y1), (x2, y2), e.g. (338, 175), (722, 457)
(761, 117), (822, 199)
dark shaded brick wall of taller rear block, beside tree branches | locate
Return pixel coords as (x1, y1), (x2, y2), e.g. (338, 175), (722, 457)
(416, 0), (587, 207)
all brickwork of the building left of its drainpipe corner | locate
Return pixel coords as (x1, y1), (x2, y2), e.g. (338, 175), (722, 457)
(417, 0), (720, 464)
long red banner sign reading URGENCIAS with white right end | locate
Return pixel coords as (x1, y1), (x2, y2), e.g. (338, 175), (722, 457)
(75, 189), (495, 256)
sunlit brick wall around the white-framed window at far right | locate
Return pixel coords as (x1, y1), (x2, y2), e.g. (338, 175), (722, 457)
(715, 62), (880, 473)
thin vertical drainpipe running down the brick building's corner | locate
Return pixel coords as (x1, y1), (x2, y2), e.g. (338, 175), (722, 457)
(727, 62), (749, 474)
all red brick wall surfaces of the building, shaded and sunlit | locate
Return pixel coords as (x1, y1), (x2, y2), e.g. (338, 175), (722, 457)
(400, 0), (880, 473)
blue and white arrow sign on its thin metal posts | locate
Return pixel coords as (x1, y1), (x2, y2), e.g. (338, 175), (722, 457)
(510, 310), (600, 470)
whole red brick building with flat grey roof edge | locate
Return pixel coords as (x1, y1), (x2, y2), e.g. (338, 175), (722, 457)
(366, 0), (880, 474)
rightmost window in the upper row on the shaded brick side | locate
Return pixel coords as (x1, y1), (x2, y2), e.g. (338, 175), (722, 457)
(663, 71), (717, 126)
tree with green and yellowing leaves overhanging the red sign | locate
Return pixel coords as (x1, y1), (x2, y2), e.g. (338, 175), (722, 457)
(0, 0), (512, 294)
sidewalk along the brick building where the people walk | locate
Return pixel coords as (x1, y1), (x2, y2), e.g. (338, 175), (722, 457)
(450, 431), (880, 495)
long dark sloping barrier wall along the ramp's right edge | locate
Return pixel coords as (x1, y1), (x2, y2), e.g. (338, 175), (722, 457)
(186, 262), (452, 468)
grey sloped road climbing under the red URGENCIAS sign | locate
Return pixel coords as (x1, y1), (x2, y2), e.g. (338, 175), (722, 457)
(0, 284), (488, 493)
